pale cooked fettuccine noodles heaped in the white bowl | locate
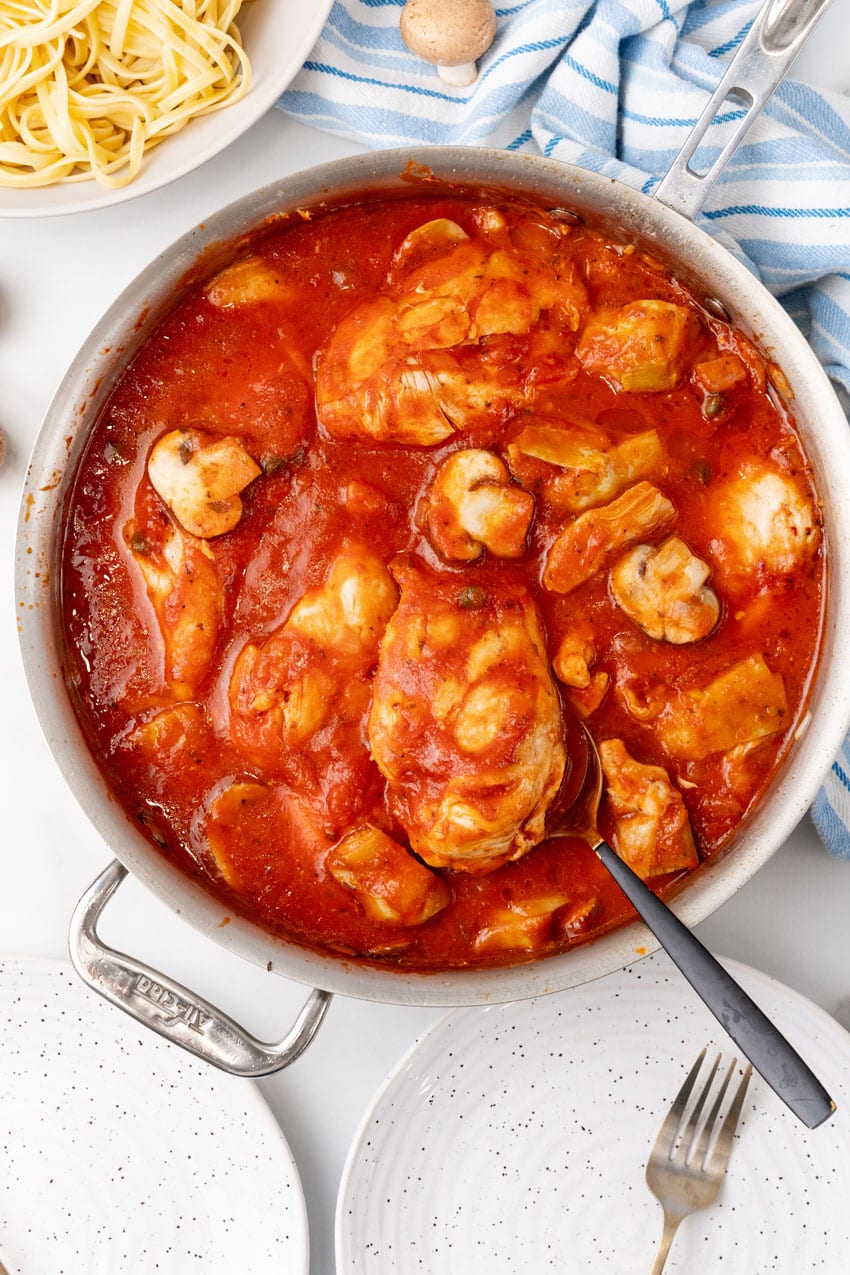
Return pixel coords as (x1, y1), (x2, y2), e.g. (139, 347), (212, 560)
(0, 0), (251, 187)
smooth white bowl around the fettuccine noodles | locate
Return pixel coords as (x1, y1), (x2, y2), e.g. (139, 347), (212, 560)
(0, 0), (333, 217)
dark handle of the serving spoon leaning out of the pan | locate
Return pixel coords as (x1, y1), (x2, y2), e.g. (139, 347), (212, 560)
(594, 842), (835, 1128)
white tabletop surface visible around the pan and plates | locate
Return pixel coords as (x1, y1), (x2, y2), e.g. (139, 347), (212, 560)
(0, 12), (850, 1275)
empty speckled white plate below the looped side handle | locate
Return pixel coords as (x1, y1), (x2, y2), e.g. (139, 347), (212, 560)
(0, 960), (308, 1275)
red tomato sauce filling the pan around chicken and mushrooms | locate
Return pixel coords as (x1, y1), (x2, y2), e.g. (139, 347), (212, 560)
(62, 194), (825, 969)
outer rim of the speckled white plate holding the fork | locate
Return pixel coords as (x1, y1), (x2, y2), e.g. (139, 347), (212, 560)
(334, 951), (850, 1275)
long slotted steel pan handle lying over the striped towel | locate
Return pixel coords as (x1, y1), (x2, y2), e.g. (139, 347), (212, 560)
(652, 0), (832, 219)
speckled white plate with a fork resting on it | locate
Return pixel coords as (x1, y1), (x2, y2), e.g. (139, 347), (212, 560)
(336, 955), (850, 1275)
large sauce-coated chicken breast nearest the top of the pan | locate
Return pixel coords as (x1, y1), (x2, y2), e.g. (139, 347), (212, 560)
(316, 210), (586, 446)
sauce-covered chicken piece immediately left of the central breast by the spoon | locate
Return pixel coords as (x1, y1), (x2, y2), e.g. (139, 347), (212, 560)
(229, 543), (398, 801)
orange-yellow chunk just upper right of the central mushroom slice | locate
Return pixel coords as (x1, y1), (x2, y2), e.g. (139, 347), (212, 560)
(507, 425), (664, 514)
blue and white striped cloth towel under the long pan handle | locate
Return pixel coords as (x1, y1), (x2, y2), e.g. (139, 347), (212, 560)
(279, 0), (850, 858)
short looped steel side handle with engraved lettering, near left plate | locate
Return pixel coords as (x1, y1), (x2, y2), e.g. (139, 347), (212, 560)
(69, 859), (331, 1076)
